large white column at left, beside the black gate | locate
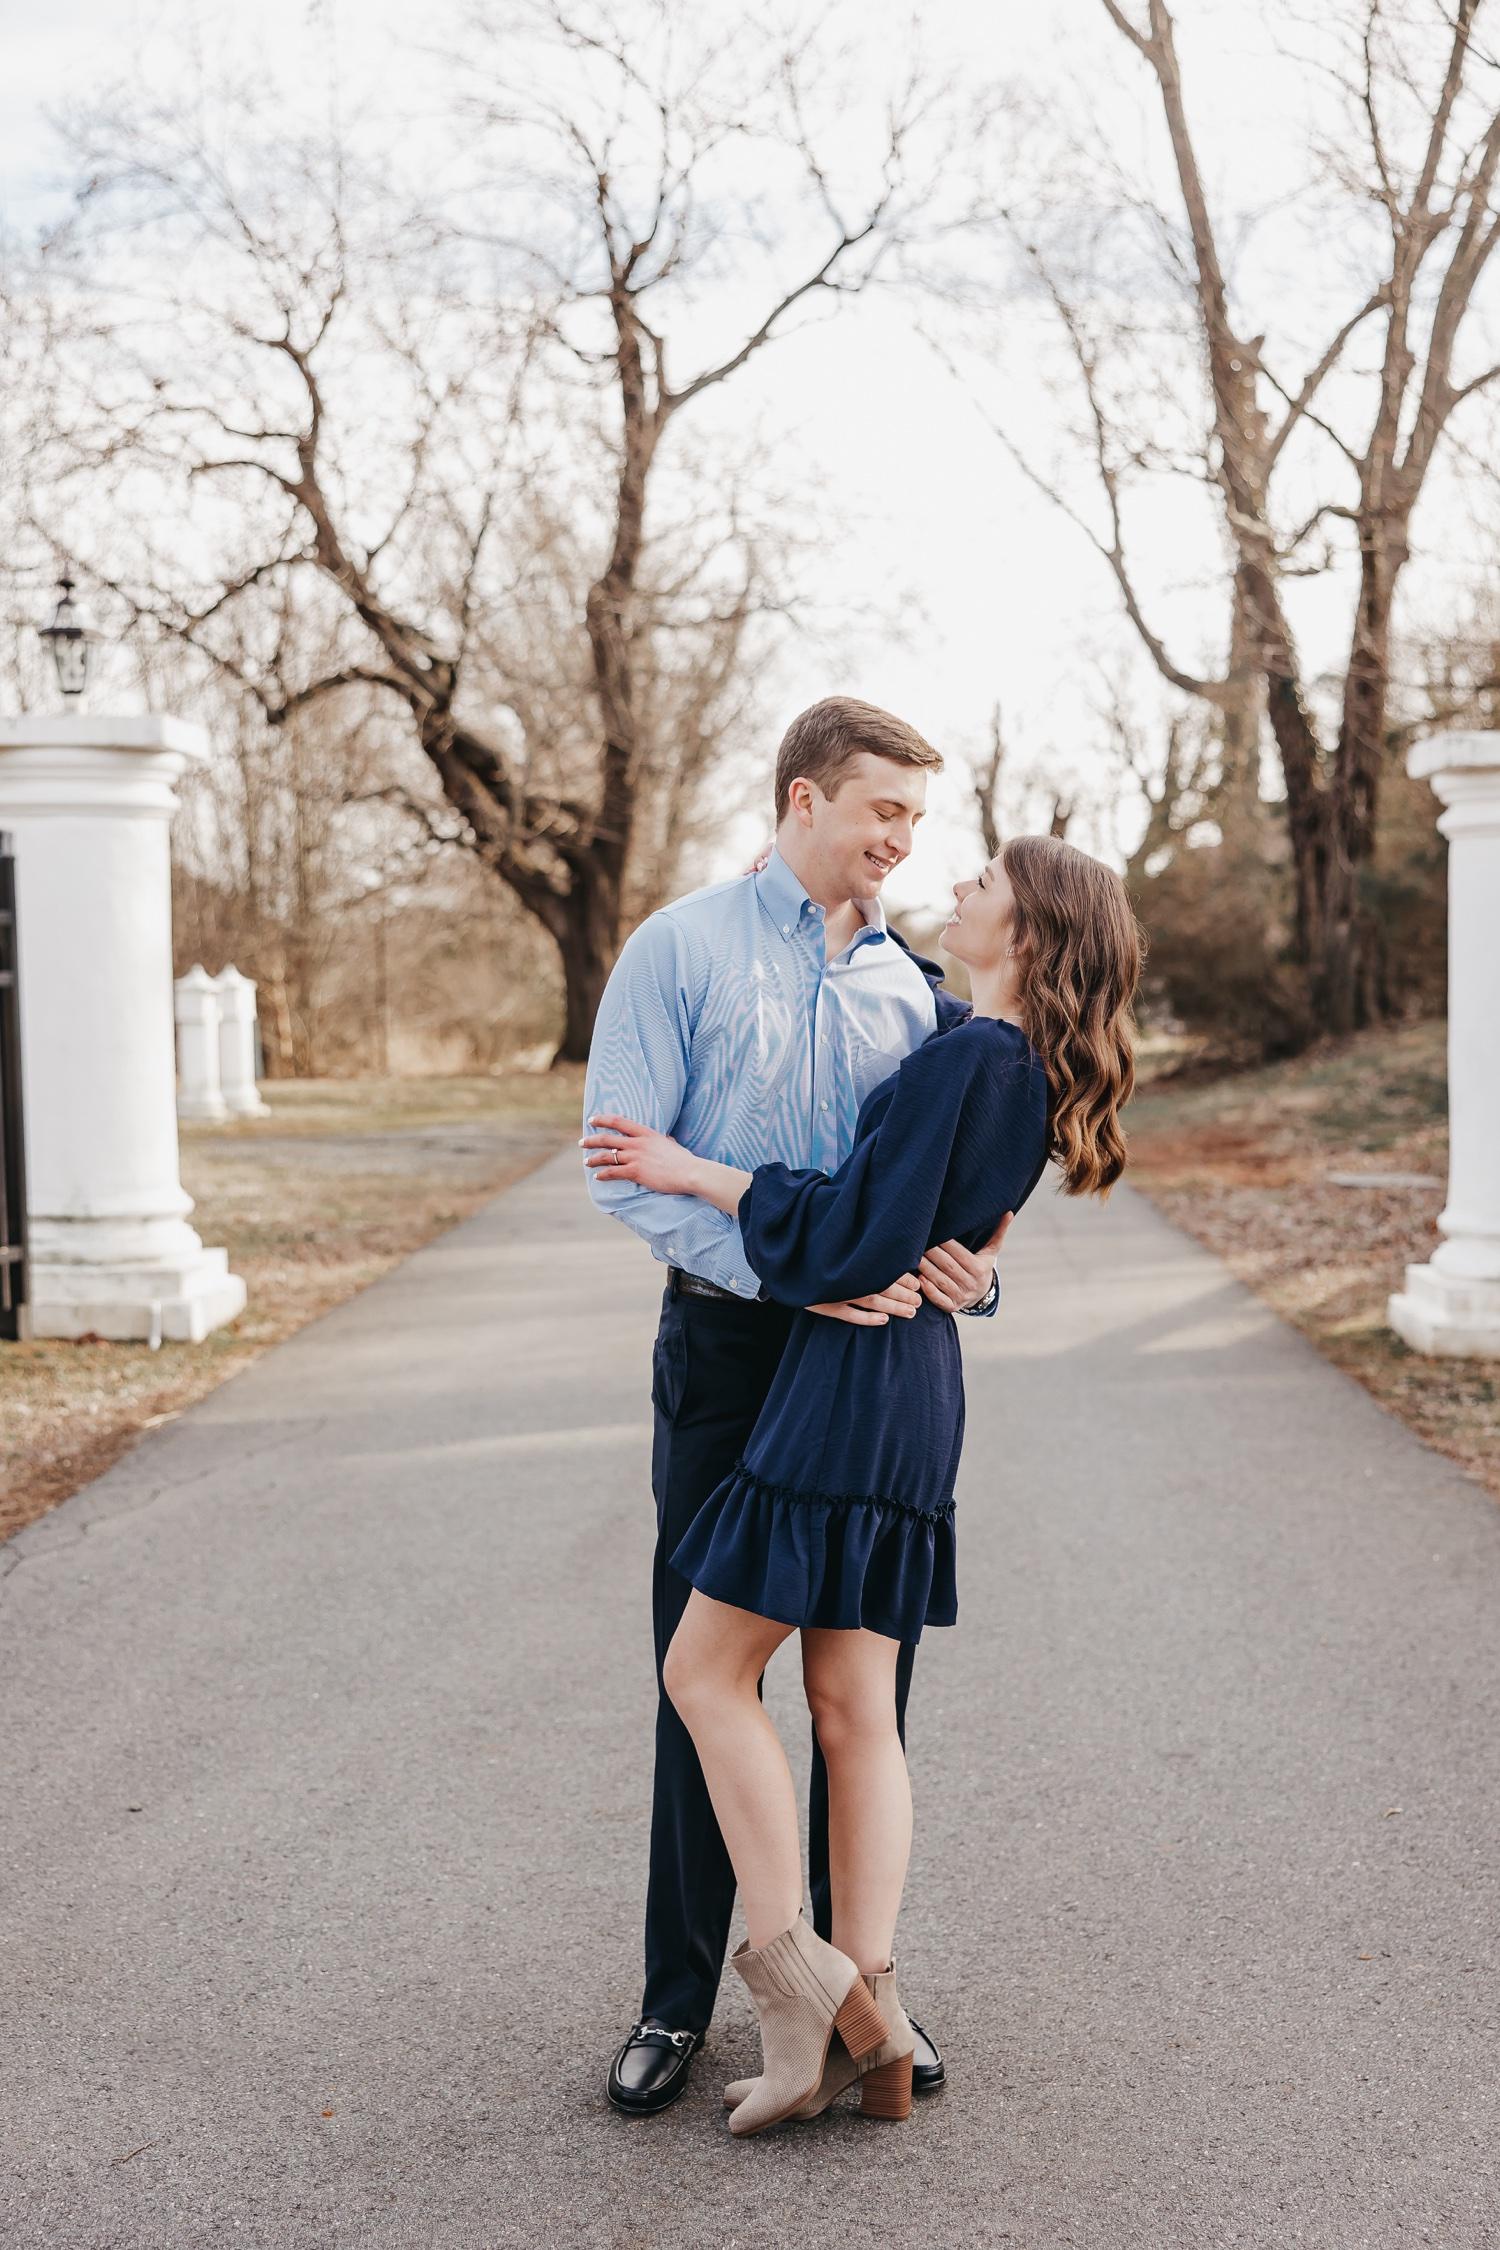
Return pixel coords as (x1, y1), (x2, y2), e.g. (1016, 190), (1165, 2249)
(0, 713), (245, 1343)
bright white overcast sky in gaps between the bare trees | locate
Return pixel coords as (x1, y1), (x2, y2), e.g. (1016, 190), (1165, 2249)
(0, 0), (1493, 907)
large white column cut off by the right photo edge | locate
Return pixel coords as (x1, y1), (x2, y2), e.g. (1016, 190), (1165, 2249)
(1388, 734), (1500, 1359)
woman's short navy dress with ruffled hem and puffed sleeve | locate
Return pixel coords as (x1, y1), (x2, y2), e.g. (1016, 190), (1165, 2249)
(670, 1017), (1048, 1640)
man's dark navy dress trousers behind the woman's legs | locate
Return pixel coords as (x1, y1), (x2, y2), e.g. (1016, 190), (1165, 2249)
(641, 1289), (915, 2032)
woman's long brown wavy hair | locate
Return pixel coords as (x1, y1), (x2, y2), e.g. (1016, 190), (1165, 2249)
(1001, 837), (1145, 1195)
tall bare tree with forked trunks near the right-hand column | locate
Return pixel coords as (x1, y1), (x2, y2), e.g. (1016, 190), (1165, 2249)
(967, 0), (1500, 1031)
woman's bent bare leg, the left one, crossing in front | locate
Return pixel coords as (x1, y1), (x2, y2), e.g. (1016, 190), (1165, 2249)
(661, 1586), (803, 1949)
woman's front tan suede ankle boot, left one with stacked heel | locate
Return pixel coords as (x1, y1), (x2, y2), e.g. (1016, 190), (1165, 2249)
(729, 1915), (886, 2133)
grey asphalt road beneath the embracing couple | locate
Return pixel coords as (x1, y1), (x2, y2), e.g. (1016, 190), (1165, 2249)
(0, 1150), (1500, 2250)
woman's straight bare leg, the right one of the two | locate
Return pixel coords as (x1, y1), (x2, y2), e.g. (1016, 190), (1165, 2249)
(803, 1627), (911, 1976)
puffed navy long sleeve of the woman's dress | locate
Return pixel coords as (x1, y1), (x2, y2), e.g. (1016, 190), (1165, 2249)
(740, 1019), (1046, 1305)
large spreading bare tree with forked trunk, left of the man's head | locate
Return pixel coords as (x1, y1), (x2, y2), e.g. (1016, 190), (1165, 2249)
(41, 0), (967, 1060)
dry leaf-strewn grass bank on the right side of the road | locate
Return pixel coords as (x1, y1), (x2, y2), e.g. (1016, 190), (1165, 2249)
(1129, 1024), (1500, 1496)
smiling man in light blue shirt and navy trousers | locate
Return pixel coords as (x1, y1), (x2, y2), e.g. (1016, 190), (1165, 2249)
(585, 695), (1005, 2115)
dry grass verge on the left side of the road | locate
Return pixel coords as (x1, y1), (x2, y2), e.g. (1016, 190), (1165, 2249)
(0, 1069), (582, 1539)
